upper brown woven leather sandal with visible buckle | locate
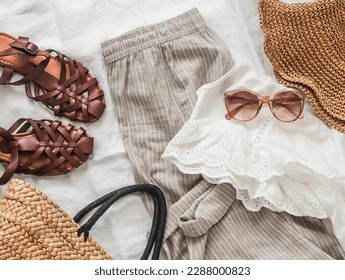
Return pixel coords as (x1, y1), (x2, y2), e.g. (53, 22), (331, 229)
(0, 32), (105, 122)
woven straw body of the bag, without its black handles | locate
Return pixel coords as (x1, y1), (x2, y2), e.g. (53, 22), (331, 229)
(0, 179), (111, 260)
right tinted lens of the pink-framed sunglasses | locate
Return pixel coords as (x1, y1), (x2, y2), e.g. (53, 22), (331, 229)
(272, 91), (303, 122)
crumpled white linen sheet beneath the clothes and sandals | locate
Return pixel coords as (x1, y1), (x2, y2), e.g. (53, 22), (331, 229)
(0, 0), (310, 259)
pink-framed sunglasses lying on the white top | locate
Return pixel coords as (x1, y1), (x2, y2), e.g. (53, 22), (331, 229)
(224, 89), (305, 122)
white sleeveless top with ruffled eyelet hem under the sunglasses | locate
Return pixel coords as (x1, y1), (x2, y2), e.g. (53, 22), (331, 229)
(162, 64), (345, 247)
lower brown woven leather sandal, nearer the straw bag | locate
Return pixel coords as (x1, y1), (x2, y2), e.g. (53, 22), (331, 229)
(0, 119), (93, 185)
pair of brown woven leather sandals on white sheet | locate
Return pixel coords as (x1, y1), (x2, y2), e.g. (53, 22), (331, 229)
(0, 32), (106, 185)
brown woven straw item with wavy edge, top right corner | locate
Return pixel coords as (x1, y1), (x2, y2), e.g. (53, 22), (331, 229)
(259, 0), (345, 132)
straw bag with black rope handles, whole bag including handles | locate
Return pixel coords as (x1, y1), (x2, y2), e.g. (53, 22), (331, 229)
(0, 179), (166, 260)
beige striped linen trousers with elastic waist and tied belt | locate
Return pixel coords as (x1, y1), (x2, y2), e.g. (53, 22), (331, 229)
(102, 8), (344, 259)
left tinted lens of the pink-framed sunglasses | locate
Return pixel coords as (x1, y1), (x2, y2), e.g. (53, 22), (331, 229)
(226, 91), (259, 121)
